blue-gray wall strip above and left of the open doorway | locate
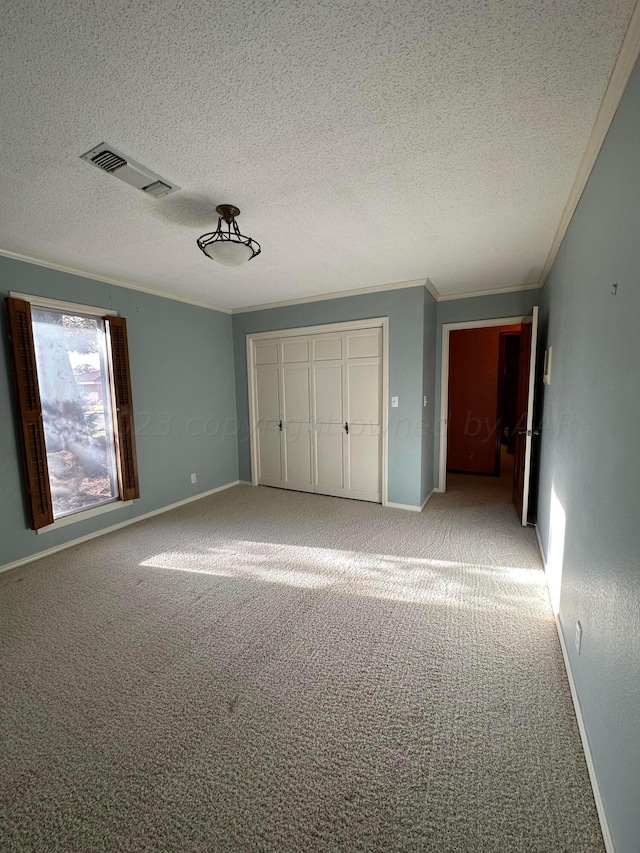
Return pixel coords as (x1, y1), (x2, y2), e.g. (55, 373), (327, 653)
(434, 289), (542, 486)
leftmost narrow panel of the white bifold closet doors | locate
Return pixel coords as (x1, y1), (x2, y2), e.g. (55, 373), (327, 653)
(255, 340), (284, 486)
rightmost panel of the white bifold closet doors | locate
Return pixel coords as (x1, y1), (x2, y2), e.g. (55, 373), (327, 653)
(344, 329), (382, 501)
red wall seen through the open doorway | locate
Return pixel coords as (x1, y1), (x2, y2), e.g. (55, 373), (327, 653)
(447, 325), (520, 474)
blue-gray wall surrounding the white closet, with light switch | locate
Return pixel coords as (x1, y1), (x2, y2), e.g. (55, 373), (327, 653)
(233, 286), (433, 506)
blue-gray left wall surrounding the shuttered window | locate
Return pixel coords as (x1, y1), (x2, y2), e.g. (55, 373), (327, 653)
(0, 257), (238, 566)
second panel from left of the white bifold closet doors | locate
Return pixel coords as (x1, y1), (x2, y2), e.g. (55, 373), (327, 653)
(280, 337), (313, 492)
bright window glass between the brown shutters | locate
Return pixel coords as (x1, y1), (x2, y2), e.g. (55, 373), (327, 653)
(31, 306), (118, 518)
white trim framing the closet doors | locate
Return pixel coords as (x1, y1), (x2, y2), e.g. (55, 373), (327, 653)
(247, 317), (389, 506)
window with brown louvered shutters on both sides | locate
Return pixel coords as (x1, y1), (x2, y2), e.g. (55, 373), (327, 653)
(7, 298), (139, 530)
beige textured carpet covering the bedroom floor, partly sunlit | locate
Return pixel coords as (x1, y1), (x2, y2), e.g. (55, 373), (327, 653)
(0, 477), (603, 853)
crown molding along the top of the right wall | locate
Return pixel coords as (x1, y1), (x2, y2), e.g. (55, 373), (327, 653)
(540, 2), (640, 285)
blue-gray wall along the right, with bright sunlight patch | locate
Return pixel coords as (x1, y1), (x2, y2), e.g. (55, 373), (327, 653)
(538, 58), (640, 853)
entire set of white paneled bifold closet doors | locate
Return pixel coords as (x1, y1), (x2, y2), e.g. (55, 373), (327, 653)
(254, 329), (382, 502)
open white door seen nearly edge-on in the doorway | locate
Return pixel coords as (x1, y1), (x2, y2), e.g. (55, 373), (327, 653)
(513, 306), (538, 527)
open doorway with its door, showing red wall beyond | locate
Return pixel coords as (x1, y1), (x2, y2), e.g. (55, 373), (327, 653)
(439, 308), (538, 525)
